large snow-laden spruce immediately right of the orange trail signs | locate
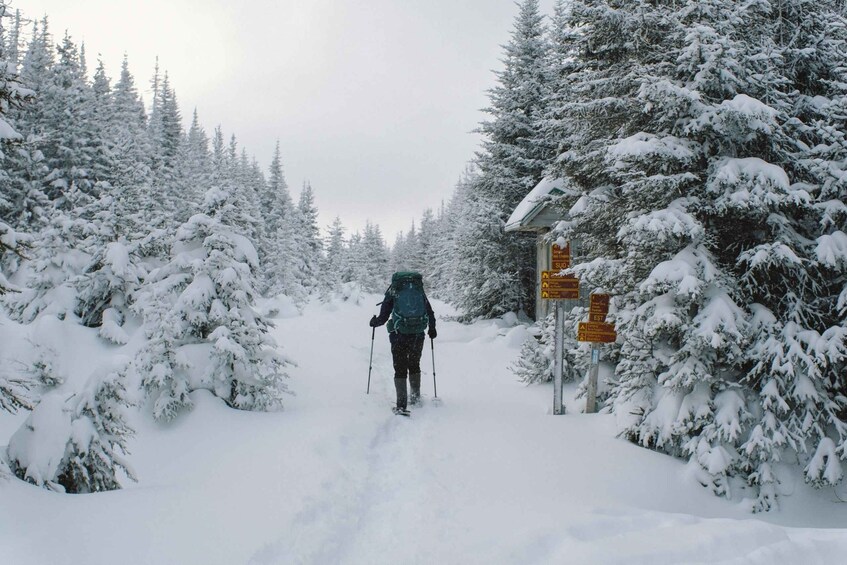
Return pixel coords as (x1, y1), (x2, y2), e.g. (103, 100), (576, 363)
(548, 2), (766, 495)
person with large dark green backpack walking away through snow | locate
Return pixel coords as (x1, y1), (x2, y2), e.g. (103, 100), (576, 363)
(370, 272), (438, 414)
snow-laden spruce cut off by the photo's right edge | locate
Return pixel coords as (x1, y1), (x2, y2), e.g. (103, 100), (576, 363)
(736, 1), (847, 508)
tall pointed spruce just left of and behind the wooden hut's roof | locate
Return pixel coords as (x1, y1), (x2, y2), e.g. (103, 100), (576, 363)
(455, 0), (553, 318)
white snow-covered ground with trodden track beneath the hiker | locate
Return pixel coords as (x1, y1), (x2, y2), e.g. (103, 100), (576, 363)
(0, 296), (847, 565)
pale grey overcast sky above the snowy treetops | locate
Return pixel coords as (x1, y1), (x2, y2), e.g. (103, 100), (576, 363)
(19, 0), (552, 240)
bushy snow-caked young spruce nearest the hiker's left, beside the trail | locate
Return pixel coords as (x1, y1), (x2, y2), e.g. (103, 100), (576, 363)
(137, 188), (287, 419)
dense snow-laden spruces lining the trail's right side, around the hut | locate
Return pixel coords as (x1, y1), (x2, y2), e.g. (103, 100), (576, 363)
(400, 0), (847, 510)
